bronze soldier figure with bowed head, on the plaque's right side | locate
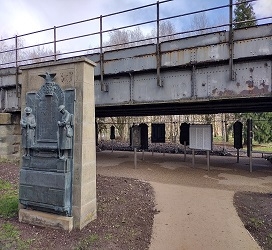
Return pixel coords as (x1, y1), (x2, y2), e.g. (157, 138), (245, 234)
(58, 105), (73, 158)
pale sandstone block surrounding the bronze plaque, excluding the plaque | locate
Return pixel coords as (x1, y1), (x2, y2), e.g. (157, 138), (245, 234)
(20, 57), (96, 230)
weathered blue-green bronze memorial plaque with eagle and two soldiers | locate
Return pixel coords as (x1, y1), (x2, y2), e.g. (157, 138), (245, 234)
(19, 73), (75, 216)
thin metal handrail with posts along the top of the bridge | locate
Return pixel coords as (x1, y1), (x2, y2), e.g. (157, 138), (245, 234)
(0, 0), (272, 67)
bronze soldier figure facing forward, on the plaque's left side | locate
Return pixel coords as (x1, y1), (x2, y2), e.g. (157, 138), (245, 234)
(20, 107), (36, 156)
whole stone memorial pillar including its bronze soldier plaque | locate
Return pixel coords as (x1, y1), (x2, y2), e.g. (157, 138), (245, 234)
(19, 57), (96, 231)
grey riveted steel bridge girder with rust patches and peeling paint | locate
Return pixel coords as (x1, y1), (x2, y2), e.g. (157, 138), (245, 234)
(0, 24), (272, 116)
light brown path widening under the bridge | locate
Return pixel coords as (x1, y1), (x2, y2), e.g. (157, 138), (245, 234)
(97, 152), (272, 250)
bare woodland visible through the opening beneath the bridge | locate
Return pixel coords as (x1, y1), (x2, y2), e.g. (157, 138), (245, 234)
(96, 113), (271, 174)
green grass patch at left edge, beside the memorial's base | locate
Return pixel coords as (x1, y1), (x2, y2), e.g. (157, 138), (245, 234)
(0, 180), (18, 218)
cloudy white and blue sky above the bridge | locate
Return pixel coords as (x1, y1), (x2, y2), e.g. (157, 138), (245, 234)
(0, 0), (272, 52)
